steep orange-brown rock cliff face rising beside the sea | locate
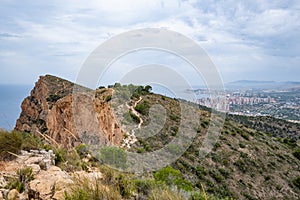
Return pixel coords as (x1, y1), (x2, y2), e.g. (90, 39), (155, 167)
(15, 75), (124, 148)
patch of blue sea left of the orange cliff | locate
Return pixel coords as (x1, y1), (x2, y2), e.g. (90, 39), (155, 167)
(0, 85), (33, 130)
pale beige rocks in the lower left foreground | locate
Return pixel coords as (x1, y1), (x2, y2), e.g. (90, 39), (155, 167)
(0, 150), (102, 200)
